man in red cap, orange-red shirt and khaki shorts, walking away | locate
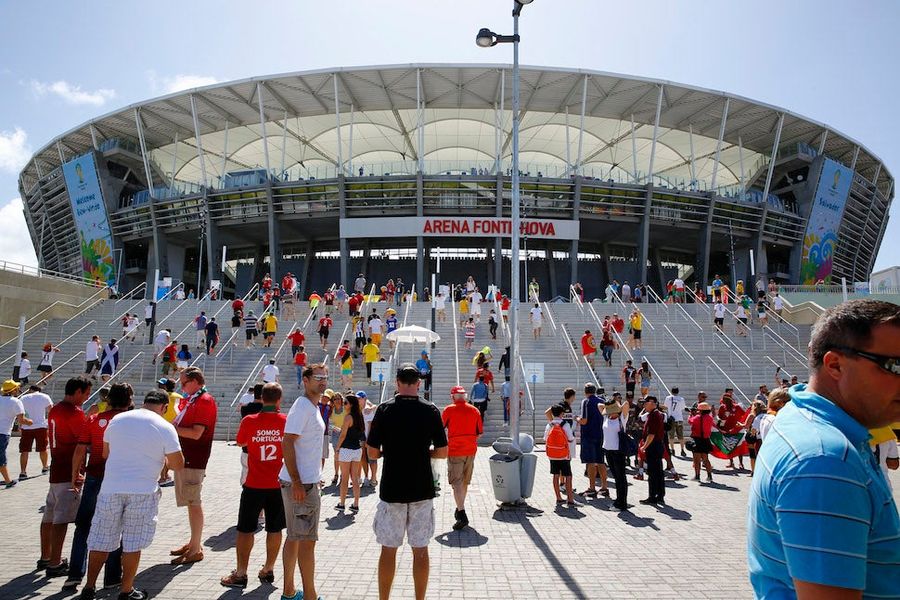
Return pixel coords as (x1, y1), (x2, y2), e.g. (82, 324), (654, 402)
(441, 385), (484, 531)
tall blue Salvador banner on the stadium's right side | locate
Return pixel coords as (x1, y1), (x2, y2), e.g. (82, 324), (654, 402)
(800, 158), (853, 285)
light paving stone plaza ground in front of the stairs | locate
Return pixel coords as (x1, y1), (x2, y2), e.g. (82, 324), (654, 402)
(0, 442), (900, 600)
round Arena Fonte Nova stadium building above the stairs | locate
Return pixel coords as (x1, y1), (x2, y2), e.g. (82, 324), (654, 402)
(19, 64), (894, 296)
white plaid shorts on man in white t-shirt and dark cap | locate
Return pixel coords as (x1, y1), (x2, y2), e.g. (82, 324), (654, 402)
(88, 490), (162, 552)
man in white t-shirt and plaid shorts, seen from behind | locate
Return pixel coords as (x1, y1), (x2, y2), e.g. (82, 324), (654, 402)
(81, 390), (184, 600)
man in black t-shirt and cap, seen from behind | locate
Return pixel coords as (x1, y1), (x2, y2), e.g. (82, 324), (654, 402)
(366, 363), (447, 599)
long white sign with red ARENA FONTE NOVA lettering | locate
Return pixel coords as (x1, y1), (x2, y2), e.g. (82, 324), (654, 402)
(340, 217), (579, 240)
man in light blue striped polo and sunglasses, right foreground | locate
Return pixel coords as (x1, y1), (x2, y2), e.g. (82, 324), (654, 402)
(747, 300), (900, 600)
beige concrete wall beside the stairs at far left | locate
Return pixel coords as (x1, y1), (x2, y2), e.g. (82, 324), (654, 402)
(0, 270), (105, 343)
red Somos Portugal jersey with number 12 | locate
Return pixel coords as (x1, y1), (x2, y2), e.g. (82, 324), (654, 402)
(237, 407), (287, 490)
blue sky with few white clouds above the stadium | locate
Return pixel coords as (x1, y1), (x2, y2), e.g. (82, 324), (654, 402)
(0, 0), (900, 269)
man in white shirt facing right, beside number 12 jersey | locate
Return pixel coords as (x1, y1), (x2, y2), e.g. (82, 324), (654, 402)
(278, 363), (328, 598)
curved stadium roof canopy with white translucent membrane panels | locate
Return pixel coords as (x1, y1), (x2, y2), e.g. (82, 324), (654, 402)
(21, 64), (891, 194)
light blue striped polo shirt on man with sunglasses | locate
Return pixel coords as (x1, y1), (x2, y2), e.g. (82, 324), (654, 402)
(747, 385), (900, 598)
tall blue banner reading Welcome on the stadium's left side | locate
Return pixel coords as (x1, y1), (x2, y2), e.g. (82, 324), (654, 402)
(62, 153), (116, 285)
